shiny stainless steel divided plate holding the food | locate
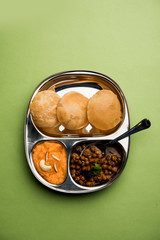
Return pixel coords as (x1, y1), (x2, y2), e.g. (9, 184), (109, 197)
(24, 71), (130, 194)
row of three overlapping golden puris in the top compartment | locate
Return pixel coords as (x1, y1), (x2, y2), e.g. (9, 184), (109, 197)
(30, 89), (122, 135)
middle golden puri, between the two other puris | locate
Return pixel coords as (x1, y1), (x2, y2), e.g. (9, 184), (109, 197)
(57, 92), (88, 130)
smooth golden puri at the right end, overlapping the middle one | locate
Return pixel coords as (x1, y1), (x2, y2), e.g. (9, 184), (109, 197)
(87, 90), (122, 130)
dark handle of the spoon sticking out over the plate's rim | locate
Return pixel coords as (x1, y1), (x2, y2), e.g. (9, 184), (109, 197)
(107, 118), (151, 145)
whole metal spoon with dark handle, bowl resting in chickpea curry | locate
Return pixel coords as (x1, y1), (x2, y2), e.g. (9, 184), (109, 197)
(81, 118), (151, 156)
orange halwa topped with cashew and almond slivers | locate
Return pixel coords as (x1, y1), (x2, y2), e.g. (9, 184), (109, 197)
(32, 141), (67, 185)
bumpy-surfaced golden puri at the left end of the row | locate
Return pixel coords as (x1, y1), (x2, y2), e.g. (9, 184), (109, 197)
(30, 90), (60, 128)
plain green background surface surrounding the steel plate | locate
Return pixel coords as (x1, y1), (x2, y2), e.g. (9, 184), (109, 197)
(0, 0), (160, 240)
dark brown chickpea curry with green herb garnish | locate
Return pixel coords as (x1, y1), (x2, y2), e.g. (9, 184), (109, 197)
(70, 142), (124, 187)
